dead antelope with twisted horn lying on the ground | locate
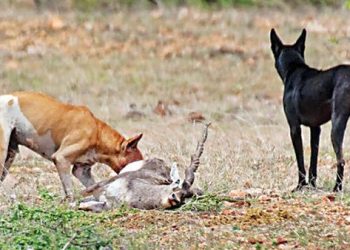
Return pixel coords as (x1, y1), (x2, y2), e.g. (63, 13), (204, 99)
(80, 124), (209, 211)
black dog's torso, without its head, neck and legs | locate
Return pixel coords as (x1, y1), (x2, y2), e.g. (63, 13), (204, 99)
(292, 65), (350, 126)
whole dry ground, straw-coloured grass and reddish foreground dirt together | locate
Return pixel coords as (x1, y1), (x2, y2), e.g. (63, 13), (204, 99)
(0, 4), (350, 249)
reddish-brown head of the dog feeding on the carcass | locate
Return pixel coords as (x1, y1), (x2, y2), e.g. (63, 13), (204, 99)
(102, 134), (143, 174)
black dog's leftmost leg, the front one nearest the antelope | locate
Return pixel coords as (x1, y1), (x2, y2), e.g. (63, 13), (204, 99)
(290, 125), (307, 191)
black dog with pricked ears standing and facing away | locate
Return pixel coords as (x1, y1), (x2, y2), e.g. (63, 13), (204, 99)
(270, 29), (350, 191)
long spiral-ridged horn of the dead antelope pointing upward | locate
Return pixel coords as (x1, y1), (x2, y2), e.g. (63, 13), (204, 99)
(182, 123), (210, 190)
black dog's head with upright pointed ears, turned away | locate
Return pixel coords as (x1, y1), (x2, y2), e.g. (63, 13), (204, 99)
(270, 29), (306, 80)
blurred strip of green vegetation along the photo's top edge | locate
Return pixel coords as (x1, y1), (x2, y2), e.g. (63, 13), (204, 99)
(0, 0), (350, 11)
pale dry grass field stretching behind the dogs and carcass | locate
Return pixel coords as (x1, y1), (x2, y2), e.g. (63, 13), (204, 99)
(0, 4), (350, 249)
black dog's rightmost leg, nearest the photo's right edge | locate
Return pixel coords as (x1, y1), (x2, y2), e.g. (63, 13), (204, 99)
(331, 115), (348, 192)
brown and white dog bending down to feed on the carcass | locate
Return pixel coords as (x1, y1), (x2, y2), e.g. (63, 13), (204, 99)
(0, 92), (143, 198)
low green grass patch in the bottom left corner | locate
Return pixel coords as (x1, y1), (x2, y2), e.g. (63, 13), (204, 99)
(0, 201), (131, 249)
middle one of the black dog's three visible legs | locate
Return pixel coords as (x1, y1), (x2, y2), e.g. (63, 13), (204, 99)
(309, 127), (321, 187)
